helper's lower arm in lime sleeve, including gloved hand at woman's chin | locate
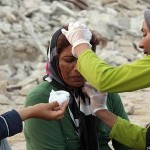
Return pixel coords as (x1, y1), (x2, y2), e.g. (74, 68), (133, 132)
(83, 84), (150, 150)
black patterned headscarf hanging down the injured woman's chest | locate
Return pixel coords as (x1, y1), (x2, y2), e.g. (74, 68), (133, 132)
(44, 29), (99, 150)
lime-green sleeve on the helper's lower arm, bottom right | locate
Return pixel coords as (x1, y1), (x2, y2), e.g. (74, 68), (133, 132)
(110, 117), (147, 150)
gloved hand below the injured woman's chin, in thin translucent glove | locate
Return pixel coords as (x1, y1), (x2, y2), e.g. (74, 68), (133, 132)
(82, 83), (107, 114)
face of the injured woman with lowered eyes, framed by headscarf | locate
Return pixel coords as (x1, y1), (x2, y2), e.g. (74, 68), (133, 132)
(59, 45), (85, 88)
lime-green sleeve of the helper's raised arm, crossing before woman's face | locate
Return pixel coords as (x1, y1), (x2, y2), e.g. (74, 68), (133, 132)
(77, 50), (150, 93)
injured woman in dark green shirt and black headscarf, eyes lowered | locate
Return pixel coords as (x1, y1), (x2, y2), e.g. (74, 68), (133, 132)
(24, 29), (132, 150)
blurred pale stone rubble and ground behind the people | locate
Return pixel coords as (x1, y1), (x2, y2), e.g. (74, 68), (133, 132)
(0, 0), (150, 150)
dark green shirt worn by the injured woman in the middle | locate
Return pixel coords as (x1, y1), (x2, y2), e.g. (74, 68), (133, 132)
(24, 81), (132, 150)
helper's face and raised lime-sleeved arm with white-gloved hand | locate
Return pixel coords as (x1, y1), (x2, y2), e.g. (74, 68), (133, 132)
(62, 9), (150, 92)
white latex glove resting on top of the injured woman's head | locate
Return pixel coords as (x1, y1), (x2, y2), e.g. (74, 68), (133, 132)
(61, 22), (92, 57)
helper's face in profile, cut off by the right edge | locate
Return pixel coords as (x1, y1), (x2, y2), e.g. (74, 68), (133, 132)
(139, 21), (150, 55)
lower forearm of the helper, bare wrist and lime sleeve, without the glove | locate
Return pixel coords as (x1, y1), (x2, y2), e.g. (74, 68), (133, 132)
(96, 110), (147, 150)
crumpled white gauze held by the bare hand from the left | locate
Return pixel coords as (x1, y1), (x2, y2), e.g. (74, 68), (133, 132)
(49, 90), (70, 106)
